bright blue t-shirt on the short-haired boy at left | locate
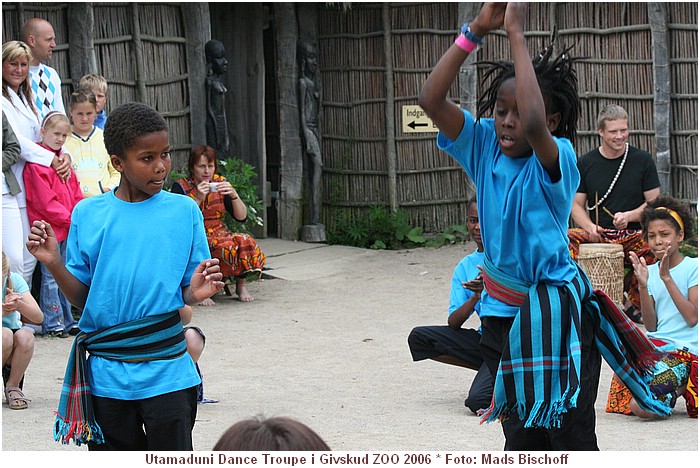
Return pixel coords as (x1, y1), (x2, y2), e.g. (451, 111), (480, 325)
(66, 191), (209, 400)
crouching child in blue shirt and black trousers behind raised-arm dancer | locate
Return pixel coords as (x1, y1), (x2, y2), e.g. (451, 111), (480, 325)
(408, 197), (493, 414)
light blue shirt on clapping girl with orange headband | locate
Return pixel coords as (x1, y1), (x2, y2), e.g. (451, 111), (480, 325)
(647, 257), (698, 356)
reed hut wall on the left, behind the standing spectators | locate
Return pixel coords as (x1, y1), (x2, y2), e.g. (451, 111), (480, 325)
(2, 3), (191, 170)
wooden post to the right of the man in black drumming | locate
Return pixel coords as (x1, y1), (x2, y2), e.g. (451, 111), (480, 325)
(647, 2), (671, 193)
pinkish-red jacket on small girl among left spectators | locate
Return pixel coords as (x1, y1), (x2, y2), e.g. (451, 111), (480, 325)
(23, 145), (83, 242)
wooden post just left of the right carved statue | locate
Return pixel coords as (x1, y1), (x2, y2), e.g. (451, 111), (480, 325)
(275, 3), (304, 240)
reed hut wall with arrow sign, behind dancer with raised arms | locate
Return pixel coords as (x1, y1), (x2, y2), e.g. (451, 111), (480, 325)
(319, 3), (698, 232)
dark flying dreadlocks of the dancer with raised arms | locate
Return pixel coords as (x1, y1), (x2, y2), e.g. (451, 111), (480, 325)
(477, 30), (581, 143)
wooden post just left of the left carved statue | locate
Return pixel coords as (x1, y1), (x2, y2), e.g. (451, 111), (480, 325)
(177, 2), (211, 154)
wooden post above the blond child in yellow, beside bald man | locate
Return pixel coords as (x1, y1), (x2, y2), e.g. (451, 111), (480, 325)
(67, 3), (98, 81)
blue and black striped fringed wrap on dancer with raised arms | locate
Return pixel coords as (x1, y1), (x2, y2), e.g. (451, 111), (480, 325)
(481, 258), (669, 428)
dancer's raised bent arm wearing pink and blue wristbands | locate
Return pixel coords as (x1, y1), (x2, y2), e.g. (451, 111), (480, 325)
(418, 3), (506, 140)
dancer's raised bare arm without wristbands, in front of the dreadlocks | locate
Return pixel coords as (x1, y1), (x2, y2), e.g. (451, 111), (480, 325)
(504, 3), (561, 182)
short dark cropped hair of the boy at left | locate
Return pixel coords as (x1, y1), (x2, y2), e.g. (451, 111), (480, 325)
(104, 102), (168, 159)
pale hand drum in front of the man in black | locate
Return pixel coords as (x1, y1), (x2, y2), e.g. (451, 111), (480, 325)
(578, 244), (625, 308)
